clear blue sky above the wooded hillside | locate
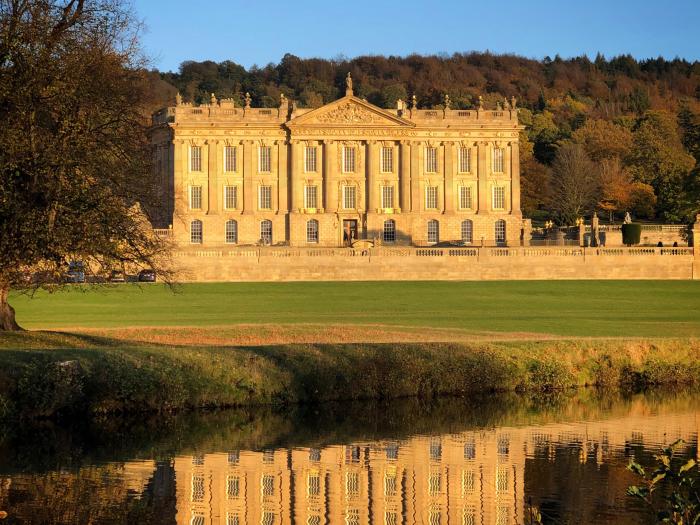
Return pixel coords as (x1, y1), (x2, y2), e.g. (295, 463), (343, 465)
(131, 0), (700, 71)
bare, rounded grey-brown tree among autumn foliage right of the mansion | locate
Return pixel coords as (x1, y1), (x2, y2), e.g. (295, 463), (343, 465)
(551, 144), (601, 224)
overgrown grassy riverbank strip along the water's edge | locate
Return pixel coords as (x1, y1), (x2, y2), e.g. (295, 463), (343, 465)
(0, 332), (700, 417)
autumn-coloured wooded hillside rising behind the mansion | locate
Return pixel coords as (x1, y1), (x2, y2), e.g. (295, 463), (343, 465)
(152, 53), (700, 223)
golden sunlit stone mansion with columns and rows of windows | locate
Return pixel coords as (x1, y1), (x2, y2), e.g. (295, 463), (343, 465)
(151, 75), (523, 247)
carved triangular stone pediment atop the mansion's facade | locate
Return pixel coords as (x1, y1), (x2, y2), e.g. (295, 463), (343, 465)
(287, 96), (415, 127)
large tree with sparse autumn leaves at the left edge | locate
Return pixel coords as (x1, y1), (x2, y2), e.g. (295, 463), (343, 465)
(0, 0), (173, 330)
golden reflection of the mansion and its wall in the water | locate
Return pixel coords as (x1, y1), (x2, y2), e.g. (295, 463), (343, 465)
(175, 414), (698, 525)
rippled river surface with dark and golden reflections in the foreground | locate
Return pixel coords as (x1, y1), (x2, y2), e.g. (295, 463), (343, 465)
(0, 392), (700, 525)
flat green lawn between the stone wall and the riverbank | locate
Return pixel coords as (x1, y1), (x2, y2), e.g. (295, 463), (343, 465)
(11, 281), (700, 337)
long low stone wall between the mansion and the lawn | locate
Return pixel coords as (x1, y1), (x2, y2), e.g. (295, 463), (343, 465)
(174, 247), (700, 282)
